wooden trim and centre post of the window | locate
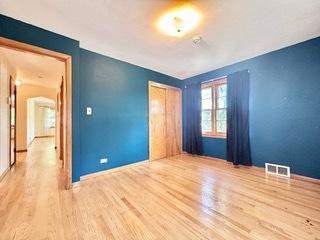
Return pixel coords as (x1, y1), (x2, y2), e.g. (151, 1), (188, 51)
(201, 78), (227, 139)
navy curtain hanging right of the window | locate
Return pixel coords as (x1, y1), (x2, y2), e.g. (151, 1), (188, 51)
(227, 70), (251, 166)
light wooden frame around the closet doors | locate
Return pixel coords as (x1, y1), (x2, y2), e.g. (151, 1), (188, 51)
(148, 80), (183, 161)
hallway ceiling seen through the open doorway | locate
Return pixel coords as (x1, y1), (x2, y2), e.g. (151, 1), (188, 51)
(0, 47), (65, 89)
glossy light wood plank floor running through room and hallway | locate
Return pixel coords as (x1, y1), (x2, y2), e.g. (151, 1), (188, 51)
(0, 139), (320, 240)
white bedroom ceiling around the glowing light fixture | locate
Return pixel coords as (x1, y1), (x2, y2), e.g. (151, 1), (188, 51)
(0, 0), (320, 79)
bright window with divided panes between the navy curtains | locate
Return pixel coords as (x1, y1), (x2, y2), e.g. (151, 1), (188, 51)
(201, 79), (227, 137)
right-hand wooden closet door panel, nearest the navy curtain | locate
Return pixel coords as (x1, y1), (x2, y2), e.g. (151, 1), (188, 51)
(166, 88), (182, 157)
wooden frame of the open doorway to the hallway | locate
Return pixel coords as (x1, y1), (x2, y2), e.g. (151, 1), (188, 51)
(0, 37), (72, 189)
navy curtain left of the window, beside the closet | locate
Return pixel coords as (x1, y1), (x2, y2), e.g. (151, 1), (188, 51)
(185, 84), (202, 155)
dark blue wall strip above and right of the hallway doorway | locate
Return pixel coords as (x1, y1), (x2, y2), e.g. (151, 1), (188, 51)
(0, 14), (81, 181)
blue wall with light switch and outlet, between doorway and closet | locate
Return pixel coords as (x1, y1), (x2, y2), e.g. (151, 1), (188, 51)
(80, 49), (182, 174)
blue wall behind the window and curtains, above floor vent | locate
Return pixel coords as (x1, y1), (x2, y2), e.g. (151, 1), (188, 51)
(184, 38), (320, 178)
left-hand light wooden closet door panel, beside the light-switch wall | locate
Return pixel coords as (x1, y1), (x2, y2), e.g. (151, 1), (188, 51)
(149, 86), (167, 160)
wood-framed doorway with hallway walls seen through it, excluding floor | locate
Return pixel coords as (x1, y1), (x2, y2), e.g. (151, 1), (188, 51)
(0, 38), (72, 189)
